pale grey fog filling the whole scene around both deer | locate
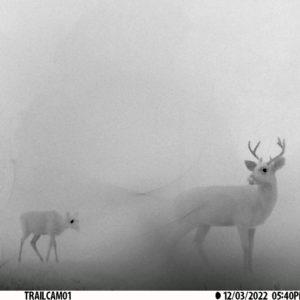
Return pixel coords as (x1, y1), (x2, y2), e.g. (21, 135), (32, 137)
(0, 0), (300, 289)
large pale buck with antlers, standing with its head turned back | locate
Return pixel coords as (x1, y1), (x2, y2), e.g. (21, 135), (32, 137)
(166, 138), (285, 271)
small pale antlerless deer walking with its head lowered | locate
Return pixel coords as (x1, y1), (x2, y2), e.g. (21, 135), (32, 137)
(19, 210), (79, 262)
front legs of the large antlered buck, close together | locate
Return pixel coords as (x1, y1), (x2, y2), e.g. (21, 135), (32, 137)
(238, 227), (255, 272)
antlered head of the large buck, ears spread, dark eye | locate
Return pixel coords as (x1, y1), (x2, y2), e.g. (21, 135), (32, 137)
(245, 138), (285, 185)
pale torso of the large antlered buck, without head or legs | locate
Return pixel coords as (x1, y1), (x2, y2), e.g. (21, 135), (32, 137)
(175, 185), (277, 227)
